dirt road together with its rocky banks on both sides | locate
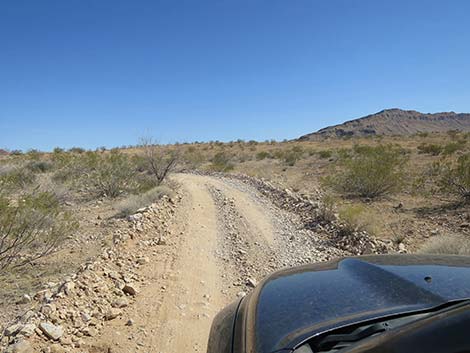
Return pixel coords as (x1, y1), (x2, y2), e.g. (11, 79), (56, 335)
(3, 174), (390, 353)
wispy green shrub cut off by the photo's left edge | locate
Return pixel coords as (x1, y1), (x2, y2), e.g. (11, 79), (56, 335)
(0, 193), (77, 271)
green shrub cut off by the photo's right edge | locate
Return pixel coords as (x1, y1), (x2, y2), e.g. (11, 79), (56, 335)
(434, 153), (470, 203)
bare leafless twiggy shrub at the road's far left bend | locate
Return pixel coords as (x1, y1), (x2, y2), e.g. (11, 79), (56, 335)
(140, 138), (178, 185)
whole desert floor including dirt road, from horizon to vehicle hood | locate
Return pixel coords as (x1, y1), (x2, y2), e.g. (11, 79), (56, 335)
(0, 132), (470, 353)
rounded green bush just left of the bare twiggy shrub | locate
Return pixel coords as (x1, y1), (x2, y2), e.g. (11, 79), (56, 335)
(88, 152), (138, 197)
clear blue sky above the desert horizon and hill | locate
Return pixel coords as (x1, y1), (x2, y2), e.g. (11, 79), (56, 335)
(0, 0), (470, 150)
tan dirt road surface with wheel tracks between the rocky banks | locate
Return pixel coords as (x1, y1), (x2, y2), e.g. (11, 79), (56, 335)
(92, 174), (342, 353)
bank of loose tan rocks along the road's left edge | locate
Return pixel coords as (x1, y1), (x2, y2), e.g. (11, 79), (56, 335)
(0, 194), (181, 353)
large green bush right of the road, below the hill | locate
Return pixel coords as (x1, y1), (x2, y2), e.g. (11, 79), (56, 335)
(324, 145), (407, 198)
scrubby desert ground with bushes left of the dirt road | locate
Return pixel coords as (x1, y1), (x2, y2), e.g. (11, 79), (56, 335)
(0, 145), (178, 314)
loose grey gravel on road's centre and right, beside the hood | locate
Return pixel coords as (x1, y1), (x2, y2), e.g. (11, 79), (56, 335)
(209, 181), (350, 297)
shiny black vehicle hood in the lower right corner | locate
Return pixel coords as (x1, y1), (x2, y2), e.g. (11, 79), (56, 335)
(241, 255), (470, 353)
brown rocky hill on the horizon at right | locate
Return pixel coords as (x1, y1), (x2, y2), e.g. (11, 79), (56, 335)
(299, 109), (470, 140)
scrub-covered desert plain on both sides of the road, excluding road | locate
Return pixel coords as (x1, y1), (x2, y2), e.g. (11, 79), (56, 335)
(0, 132), (470, 336)
